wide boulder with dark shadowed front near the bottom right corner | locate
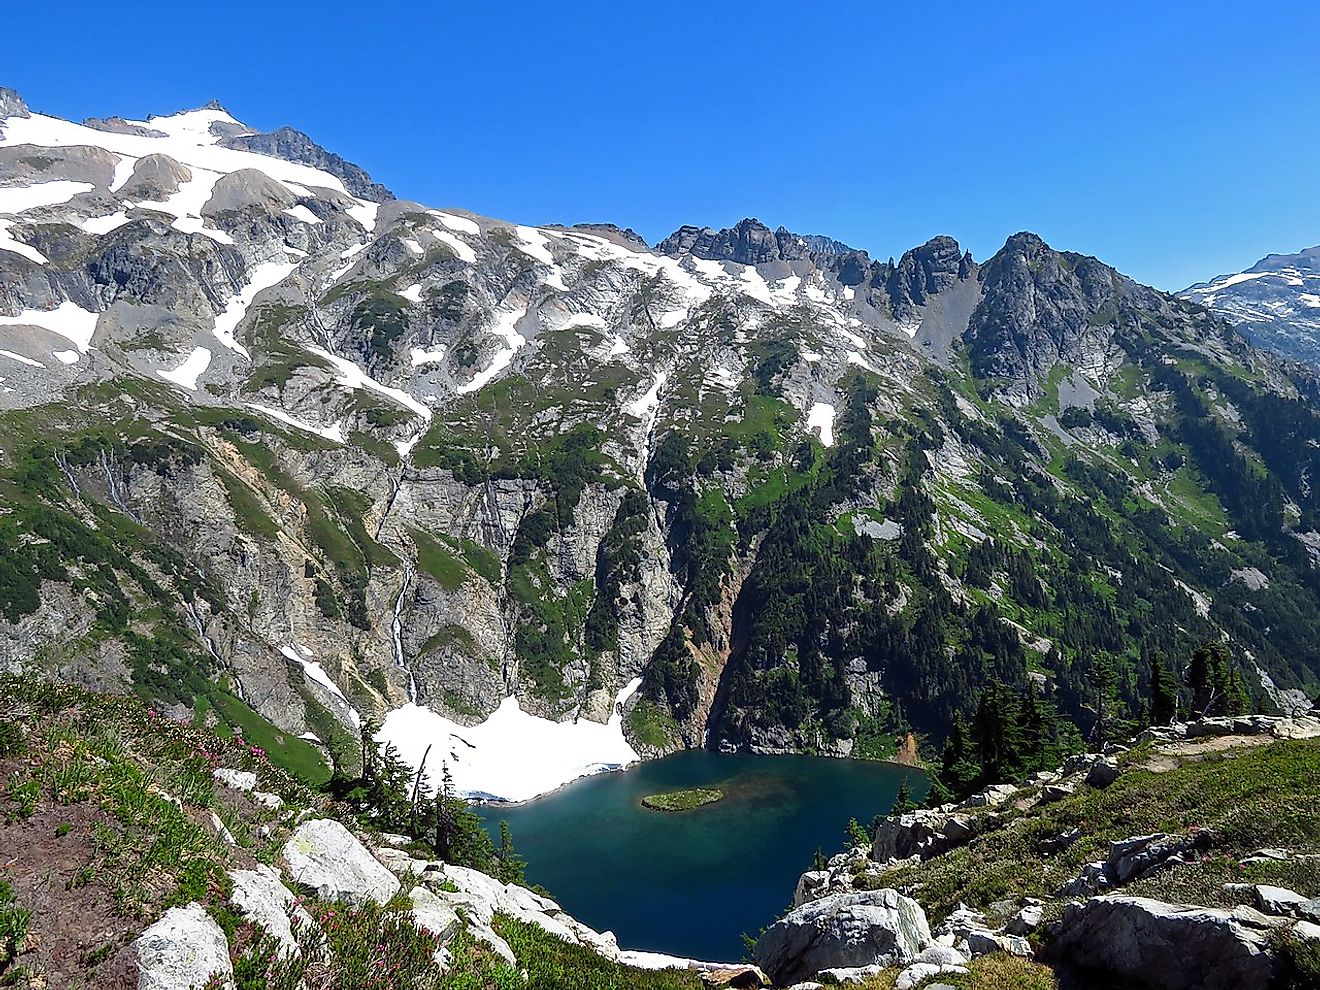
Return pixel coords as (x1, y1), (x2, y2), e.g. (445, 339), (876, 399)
(1049, 896), (1276, 990)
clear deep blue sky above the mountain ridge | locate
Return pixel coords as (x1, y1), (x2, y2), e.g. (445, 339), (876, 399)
(0, 0), (1320, 289)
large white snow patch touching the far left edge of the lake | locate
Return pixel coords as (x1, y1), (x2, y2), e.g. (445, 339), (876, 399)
(376, 677), (642, 801)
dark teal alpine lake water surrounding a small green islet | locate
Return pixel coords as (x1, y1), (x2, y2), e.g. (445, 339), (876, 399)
(477, 751), (925, 961)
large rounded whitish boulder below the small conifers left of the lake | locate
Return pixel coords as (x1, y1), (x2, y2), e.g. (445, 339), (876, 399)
(282, 818), (399, 904)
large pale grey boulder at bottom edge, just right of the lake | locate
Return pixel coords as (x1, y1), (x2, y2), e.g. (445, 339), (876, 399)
(752, 890), (931, 983)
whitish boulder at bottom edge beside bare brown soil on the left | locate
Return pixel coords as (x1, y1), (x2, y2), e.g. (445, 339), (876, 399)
(133, 903), (234, 990)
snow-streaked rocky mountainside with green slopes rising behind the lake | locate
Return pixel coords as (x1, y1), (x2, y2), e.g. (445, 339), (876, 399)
(0, 87), (1320, 807)
